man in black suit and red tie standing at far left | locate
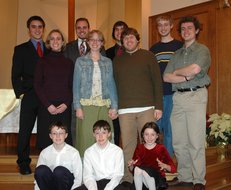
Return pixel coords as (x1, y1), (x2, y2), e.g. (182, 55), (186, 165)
(11, 16), (46, 175)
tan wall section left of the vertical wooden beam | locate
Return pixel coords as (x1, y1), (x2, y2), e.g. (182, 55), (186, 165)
(17, 0), (68, 44)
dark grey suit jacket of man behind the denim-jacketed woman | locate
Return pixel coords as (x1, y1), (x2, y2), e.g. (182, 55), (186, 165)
(64, 39), (106, 63)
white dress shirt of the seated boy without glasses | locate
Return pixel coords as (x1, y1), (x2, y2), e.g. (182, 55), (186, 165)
(83, 141), (124, 190)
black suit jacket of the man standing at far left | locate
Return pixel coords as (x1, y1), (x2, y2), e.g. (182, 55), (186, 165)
(11, 40), (47, 98)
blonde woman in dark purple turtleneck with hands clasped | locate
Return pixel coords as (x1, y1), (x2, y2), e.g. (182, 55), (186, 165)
(34, 29), (74, 149)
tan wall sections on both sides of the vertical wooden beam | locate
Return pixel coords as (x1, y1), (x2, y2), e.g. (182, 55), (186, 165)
(17, 0), (97, 44)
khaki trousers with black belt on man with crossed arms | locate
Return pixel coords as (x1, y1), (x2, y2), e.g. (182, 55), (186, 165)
(171, 88), (208, 184)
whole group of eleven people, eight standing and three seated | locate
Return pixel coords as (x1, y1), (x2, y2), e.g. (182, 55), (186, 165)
(12, 15), (211, 190)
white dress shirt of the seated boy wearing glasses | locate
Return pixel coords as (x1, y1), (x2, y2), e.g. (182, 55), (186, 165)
(35, 144), (82, 190)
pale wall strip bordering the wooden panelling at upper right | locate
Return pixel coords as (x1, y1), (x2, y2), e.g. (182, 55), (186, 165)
(141, 0), (211, 48)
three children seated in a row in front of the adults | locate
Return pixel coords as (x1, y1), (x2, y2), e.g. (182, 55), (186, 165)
(34, 120), (173, 190)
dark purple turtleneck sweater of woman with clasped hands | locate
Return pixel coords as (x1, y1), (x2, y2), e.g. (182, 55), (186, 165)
(34, 51), (74, 107)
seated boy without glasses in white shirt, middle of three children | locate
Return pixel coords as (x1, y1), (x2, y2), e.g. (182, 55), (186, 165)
(77, 120), (128, 190)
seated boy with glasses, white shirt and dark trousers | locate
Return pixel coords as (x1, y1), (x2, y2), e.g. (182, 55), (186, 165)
(34, 122), (82, 190)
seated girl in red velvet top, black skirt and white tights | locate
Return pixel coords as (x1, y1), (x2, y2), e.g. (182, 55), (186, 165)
(128, 122), (176, 190)
